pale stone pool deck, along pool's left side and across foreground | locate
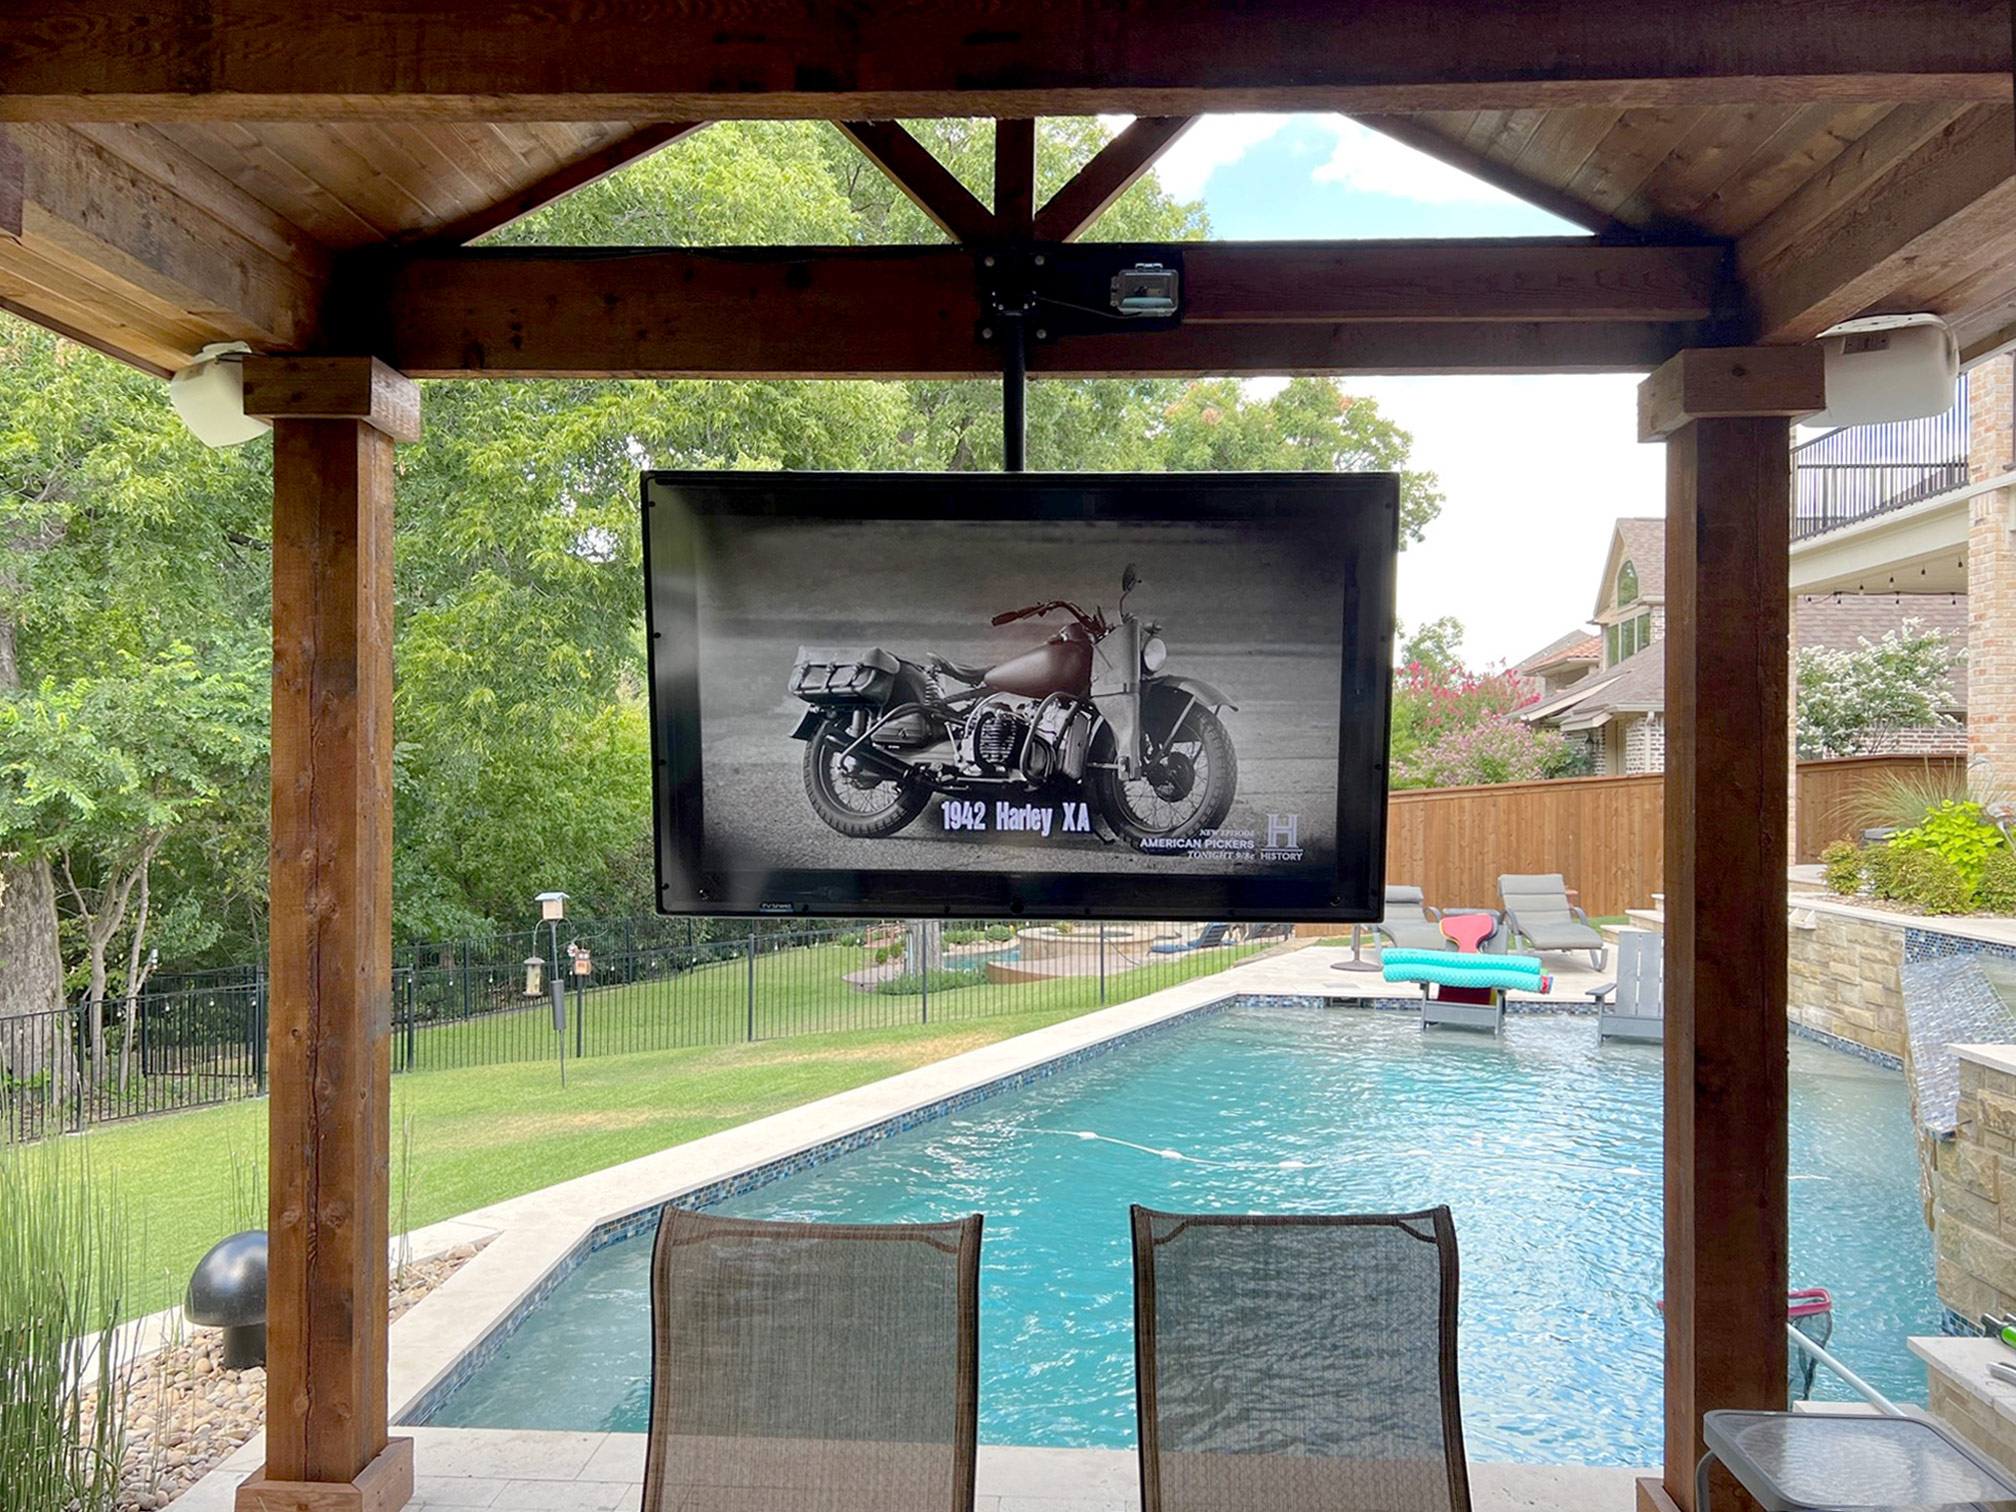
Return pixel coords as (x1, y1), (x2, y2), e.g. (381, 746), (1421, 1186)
(173, 946), (1643, 1512)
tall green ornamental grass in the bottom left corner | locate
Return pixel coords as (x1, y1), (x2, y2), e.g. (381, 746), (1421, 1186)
(0, 1141), (127, 1512)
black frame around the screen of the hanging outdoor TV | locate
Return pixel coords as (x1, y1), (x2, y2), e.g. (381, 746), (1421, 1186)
(641, 472), (1399, 923)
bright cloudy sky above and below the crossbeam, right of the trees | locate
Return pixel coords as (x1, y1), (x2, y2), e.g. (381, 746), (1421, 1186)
(1159, 115), (1665, 663)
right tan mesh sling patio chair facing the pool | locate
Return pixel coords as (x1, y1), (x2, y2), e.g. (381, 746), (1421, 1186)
(1133, 1208), (1470, 1512)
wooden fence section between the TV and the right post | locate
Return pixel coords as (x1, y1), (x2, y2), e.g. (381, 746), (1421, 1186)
(1387, 772), (1665, 915)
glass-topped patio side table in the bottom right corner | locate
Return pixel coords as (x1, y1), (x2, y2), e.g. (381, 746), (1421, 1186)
(1693, 1411), (2016, 1512)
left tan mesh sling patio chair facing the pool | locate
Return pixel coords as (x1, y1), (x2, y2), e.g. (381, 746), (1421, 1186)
(643, 1208), (980, 1512)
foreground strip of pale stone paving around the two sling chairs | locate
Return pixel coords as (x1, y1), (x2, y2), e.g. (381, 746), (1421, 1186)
(173, 1427), (1657, 1512)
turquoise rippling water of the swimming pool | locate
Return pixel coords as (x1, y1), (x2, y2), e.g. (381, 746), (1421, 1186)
(431, 1008), (1939, 1466)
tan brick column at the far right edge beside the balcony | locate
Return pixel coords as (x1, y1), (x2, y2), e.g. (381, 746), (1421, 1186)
(1968, 357), (2016, 782)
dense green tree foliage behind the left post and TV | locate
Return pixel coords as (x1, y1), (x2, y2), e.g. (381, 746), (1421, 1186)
(0, 121), (1439, 982)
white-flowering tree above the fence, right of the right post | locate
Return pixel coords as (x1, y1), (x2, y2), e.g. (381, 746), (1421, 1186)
(1796, 619), (1964, 758)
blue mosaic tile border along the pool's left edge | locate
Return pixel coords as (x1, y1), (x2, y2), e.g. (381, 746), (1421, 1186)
(399, 992), (1282, 1427)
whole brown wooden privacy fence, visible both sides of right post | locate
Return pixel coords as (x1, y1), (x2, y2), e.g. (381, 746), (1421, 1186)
(1354, 756), (1966, 917)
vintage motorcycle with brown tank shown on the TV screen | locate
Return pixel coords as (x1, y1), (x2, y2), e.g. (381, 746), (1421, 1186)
(790, 566), (1238, 849)
